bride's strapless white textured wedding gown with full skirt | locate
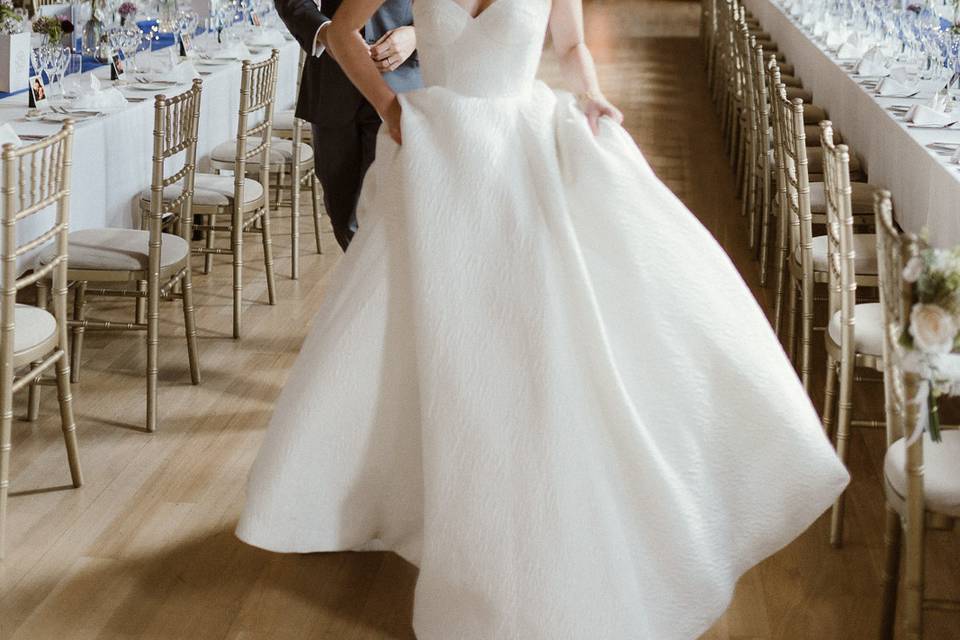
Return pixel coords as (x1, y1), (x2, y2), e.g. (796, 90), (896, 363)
(237, 0), (848, 640)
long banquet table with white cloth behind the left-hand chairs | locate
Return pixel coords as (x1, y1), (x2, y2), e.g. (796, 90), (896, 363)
(0, 33), (300, 268)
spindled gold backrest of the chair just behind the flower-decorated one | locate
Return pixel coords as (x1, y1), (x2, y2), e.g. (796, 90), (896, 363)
(820, 120), (857, 358)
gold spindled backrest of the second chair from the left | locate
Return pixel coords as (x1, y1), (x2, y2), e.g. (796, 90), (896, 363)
(146, 80), (203, 250)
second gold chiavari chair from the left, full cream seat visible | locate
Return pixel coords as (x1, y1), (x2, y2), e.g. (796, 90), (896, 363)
(45, 80), (202, 432)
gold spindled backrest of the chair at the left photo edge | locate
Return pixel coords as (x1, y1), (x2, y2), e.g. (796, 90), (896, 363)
(0, 120), (73, 358)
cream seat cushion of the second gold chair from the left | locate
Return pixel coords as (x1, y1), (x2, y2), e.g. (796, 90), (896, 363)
(54, 229), (190, 271)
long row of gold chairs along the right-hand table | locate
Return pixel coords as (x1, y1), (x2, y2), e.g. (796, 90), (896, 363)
(701, 0), (960, 639)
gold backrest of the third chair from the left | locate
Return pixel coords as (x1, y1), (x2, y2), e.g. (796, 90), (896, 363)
(234, 49), (280, 205)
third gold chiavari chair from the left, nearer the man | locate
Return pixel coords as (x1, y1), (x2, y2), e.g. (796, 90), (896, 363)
(194, 49), (280, 338)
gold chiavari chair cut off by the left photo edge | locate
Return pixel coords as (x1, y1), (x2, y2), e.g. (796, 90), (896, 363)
(0, 122), (83, 558)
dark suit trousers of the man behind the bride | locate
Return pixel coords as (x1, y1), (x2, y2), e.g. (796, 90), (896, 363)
(313, 102), (381, 251)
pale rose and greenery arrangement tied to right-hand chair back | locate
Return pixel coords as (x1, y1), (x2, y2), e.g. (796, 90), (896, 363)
(900, 248), (960, 442)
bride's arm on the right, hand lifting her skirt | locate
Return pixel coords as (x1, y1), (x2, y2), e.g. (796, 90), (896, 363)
(550, 0), (623, 134)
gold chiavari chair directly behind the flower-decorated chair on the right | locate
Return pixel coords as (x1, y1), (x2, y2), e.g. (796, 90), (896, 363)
(820, 120), (884, 547)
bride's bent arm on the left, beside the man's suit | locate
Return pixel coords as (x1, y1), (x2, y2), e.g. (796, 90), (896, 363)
(326, 0), (400, 144)
